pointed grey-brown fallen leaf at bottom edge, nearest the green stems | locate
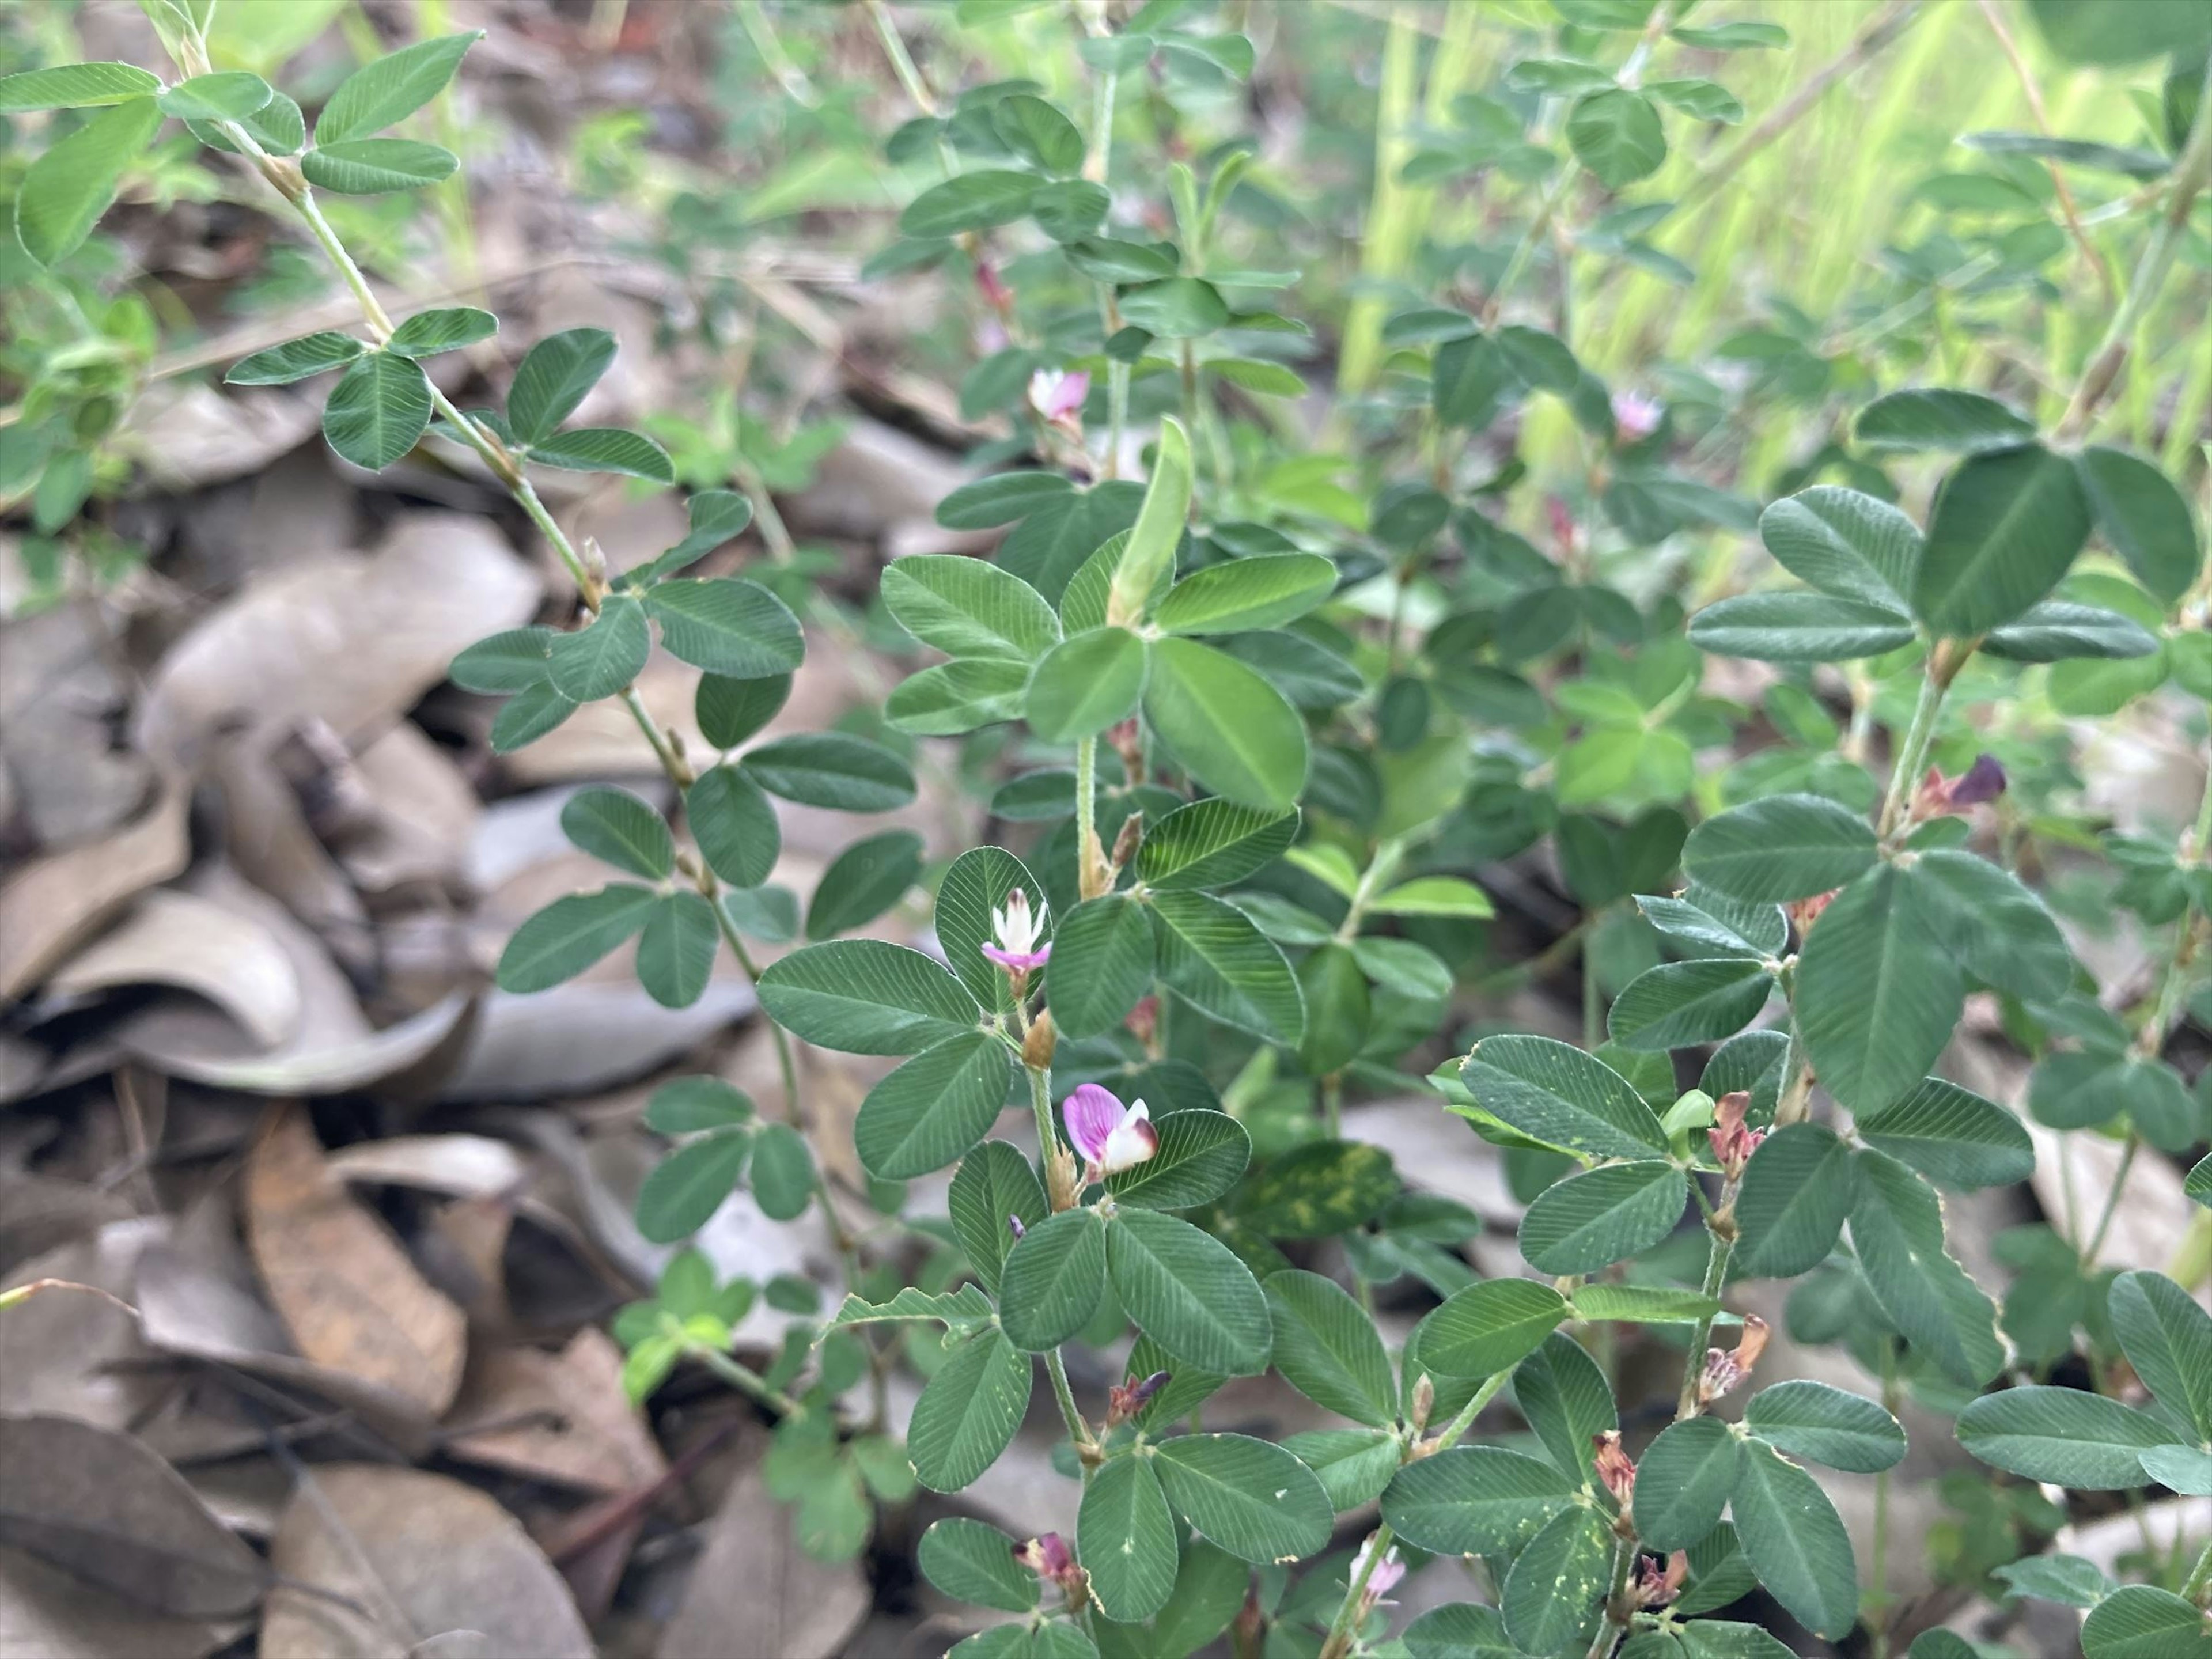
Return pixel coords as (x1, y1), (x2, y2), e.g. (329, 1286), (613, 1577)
(659, 1464), (874, 1659)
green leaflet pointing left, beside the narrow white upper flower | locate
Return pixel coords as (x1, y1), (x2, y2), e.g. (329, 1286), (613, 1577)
(761, 938), (982, 1055)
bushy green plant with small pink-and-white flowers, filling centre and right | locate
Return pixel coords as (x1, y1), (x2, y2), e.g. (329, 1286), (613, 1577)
(21, 0), (2212, 1659)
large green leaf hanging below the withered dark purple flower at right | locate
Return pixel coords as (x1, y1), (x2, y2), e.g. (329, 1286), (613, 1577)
(1791, 865), (1967, 1113)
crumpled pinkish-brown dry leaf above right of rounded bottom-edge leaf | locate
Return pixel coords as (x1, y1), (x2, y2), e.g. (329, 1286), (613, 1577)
(445, 1325), (668, 1493)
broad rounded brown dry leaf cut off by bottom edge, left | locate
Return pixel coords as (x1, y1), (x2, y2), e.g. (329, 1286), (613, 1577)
(261, 1464), (597, 1659)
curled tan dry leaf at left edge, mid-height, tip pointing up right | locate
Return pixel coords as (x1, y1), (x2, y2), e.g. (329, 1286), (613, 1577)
(0, 779), (190, 1004)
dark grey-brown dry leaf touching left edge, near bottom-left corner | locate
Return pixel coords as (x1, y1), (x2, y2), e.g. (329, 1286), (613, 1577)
(0, 1416), (268, 1619)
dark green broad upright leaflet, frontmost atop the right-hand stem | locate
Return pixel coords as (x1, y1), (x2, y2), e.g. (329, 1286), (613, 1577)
(1914, 447), (2090, 639)
